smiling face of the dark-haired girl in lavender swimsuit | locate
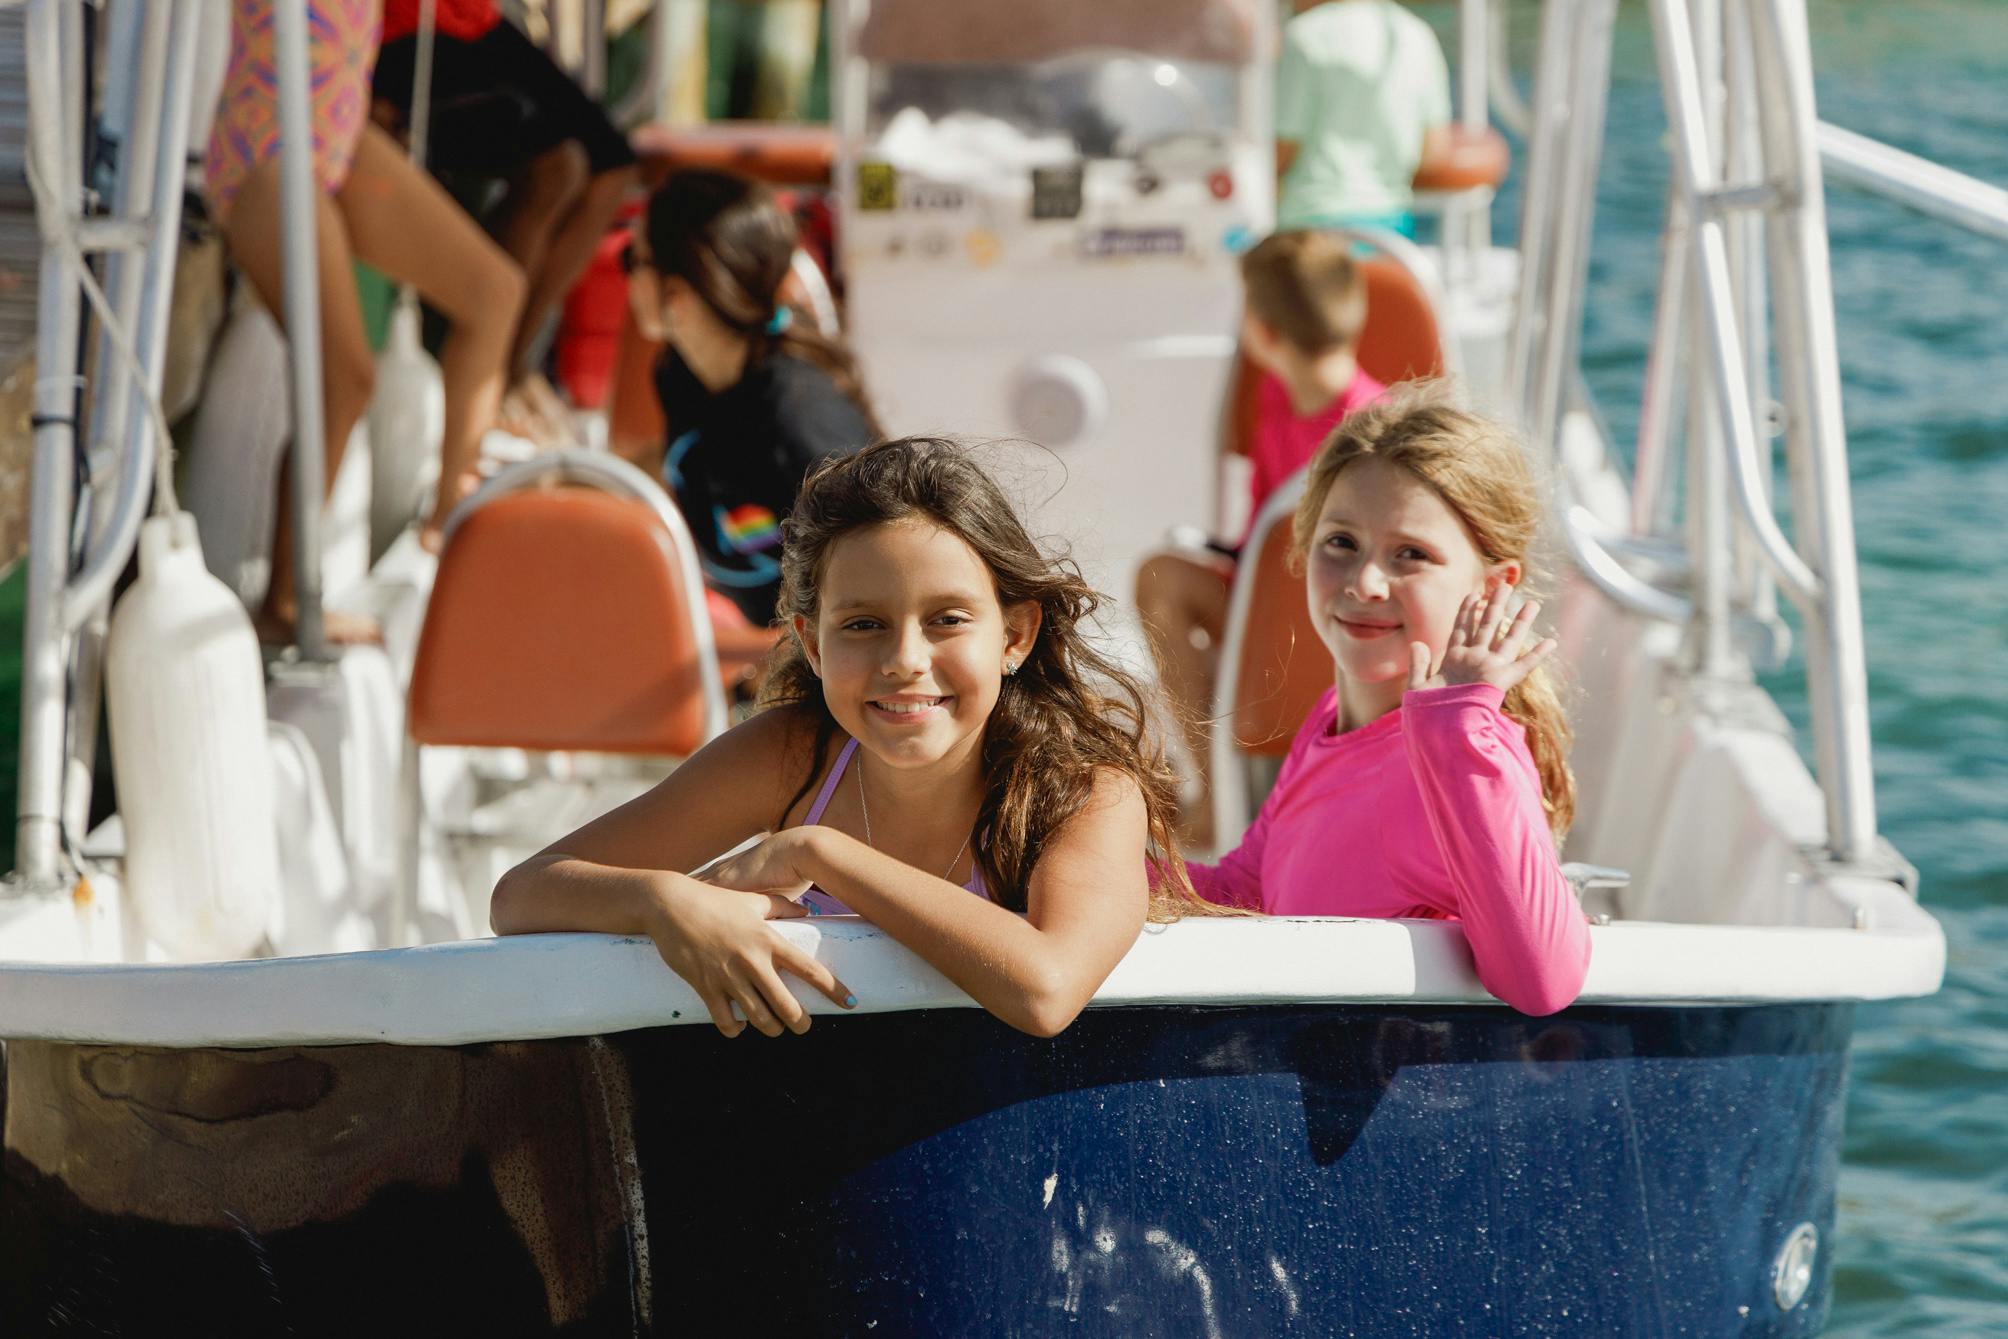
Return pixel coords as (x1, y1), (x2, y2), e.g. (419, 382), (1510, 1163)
(795, 520), (1038, 767)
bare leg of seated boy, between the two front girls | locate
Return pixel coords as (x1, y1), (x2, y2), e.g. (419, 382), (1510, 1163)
(1137, 554), (1231, 847)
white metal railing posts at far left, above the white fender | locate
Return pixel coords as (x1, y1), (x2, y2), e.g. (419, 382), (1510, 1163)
(16, 0), (201, 887)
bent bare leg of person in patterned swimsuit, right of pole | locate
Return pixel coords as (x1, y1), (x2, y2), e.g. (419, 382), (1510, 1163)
(335, 124), (522, 548)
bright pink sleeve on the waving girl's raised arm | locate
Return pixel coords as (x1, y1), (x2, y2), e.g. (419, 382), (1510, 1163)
(1402, 683), (1590, 1016)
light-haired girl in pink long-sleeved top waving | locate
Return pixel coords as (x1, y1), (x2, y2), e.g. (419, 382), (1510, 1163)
(1191, 385), (1590, 1014)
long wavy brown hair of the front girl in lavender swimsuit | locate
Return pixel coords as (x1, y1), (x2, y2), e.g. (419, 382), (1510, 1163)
(761, 438), (1211, 919)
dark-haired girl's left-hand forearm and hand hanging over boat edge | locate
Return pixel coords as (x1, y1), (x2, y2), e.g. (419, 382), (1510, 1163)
(490, 851), (855, 1036)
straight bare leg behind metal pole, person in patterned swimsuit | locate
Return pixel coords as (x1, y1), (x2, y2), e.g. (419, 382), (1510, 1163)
(223, 159), (382, 644)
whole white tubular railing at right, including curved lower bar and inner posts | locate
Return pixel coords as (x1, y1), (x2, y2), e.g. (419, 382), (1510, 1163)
(1508, 0), (1887, 863)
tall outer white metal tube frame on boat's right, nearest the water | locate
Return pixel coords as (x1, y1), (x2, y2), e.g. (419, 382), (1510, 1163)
(1635, 0), (1875, 861)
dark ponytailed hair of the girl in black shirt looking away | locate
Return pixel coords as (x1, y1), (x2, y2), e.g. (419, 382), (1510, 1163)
(643, 167), (880, 432)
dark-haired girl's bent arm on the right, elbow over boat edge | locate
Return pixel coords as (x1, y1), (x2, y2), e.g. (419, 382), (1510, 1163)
(709, 773), (1149, 1036)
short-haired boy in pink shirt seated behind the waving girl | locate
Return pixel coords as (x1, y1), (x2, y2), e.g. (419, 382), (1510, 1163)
(1137, 231), (1386, 849)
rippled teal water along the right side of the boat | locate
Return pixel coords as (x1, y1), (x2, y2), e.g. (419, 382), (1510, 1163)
(1461, 0), (2008, 1339)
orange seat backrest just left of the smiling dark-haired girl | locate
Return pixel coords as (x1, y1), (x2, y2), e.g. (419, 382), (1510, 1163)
(410, 486), (717, 757)
